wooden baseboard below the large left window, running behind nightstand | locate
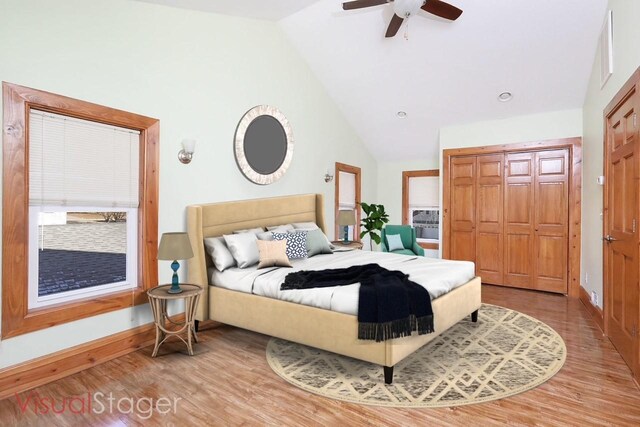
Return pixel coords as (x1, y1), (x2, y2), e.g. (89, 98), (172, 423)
(0, 313), (184, 400)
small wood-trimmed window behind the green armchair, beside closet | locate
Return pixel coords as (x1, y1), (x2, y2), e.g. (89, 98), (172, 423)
(402, 170), (440, 249)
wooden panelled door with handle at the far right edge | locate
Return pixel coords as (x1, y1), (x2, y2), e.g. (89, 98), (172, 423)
(604, 90), (640, 375)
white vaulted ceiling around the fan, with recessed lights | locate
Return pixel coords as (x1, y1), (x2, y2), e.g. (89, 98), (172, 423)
(134, 0), (607, 160)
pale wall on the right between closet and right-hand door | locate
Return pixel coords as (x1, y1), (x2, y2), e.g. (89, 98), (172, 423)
(581, 0), (640, 307)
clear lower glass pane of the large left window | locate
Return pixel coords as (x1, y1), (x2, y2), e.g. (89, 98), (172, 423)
(38, 212), (127, 296)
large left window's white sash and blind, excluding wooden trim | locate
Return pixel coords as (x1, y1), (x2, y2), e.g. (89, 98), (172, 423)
(28, 109), (140, 309)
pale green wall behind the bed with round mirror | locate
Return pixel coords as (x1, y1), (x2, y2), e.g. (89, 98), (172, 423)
(0, 0), (377, 368)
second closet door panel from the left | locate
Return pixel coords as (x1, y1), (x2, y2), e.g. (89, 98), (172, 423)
(476, 154), (504, 285)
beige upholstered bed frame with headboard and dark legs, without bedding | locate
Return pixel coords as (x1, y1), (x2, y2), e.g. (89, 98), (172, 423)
(187, 194), (481, 384)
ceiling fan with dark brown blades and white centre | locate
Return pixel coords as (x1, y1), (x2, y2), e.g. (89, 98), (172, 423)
(342, 0), (462, 37)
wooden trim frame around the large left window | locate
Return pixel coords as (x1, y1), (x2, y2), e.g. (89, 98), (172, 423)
(2, 82), (160, 338)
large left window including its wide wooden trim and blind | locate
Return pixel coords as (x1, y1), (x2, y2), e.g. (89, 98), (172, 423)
(2, 83), (159, 338)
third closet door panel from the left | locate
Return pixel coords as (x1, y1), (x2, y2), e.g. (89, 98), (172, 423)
(503, 153), (535, 289)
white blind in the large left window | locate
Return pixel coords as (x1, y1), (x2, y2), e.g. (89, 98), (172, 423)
(29, 110), (140, 208)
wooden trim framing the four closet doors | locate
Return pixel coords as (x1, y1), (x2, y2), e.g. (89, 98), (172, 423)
(441, 137), (582, 298)
